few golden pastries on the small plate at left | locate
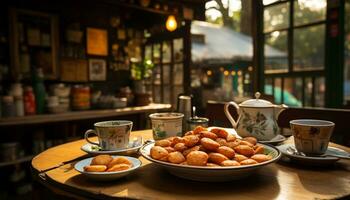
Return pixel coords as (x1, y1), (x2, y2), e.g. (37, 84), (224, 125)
(84, 155), (133, 172)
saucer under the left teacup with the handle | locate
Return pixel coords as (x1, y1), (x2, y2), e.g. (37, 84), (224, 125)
(80, 138), (143, 155)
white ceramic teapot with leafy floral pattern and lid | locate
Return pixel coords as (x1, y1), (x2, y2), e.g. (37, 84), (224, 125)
(224, 92), (287, 141)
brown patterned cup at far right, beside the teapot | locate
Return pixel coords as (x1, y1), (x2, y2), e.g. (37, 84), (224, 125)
(289, 119), (335, 155)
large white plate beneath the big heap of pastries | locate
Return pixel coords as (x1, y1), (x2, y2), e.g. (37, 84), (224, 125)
(140, 142), (281, 182)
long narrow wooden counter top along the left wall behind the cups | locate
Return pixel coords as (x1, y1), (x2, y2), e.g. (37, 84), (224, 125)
(0, 104), (171, 127)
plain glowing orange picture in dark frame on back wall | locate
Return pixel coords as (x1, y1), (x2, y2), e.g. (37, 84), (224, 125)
(86, 28), (108, 56)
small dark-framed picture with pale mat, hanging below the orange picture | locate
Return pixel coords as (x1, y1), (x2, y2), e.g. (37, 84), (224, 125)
(89, 59), (107, 81)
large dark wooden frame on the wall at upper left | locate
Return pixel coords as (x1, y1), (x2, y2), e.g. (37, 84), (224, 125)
(9, 8), (58, 79)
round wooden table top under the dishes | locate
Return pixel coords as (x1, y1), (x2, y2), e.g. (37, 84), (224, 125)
(32, 130), (350, 200)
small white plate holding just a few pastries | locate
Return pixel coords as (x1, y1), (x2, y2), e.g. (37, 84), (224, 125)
(74, 156), (142, 181)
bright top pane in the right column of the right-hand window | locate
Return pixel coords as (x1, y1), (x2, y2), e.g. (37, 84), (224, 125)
(294, 0), (327, 25)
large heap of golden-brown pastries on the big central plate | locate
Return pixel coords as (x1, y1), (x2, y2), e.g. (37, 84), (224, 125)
(150, 126), (272, 167)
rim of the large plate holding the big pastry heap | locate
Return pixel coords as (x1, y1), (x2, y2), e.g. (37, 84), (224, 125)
(140, 142), (282, 171)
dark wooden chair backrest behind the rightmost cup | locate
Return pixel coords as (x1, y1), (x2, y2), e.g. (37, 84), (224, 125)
(278, 108), (350, 146)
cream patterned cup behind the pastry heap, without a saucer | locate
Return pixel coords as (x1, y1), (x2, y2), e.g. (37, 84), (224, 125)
(149, 113), (184, 140)
